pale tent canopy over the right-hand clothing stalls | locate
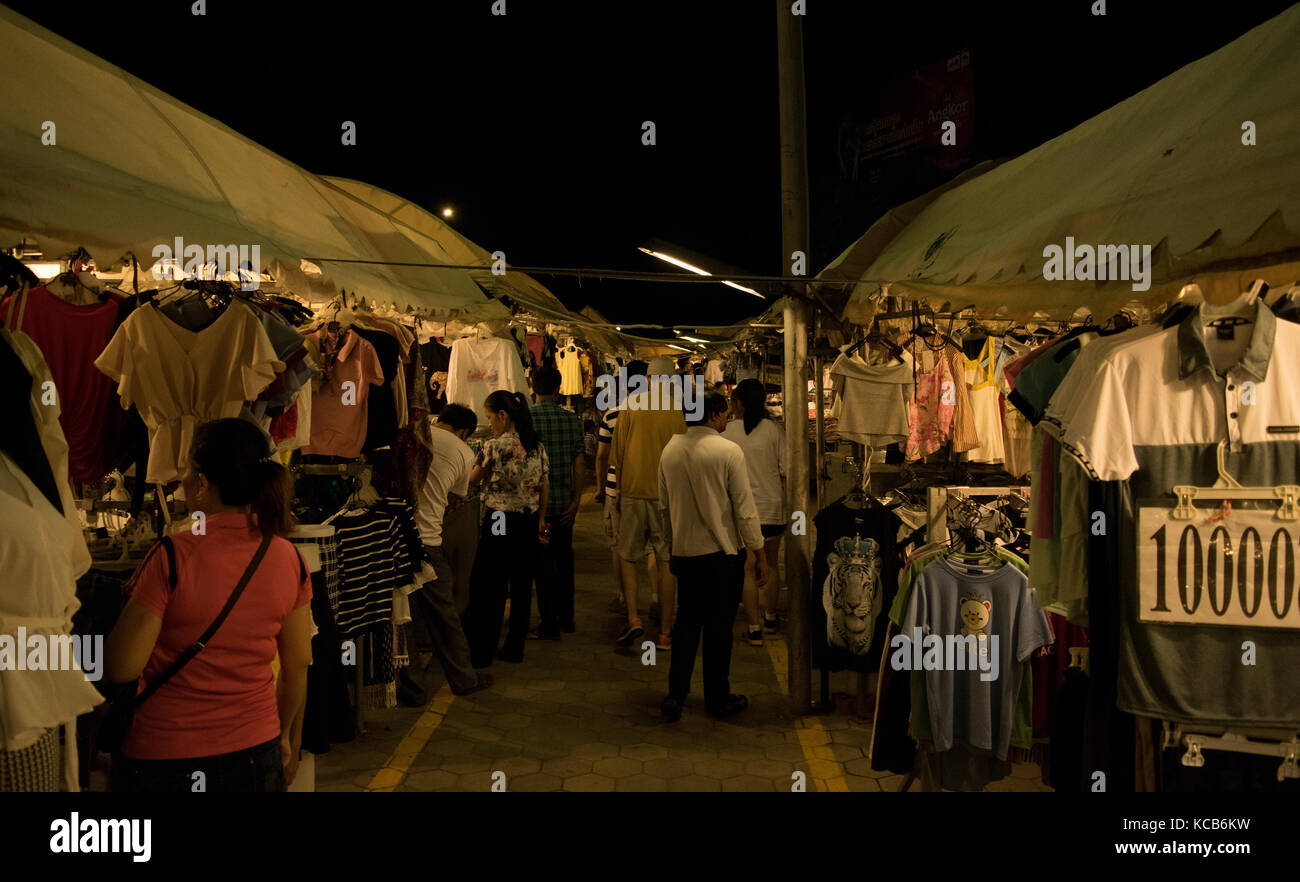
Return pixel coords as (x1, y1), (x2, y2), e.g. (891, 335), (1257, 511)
(822, 5), (1300, 321)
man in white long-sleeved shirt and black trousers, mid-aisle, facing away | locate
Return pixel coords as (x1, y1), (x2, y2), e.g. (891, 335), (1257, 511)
(659, 392), (767, 722)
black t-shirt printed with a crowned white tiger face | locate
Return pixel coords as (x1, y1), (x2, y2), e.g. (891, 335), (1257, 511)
(809, 500), (902, 671)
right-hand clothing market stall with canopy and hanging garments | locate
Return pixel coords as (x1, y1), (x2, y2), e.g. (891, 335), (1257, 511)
(790, 0), (1300, 791)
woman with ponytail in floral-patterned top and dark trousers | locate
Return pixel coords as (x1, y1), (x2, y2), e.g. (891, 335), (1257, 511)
(464, 390), (550, 669)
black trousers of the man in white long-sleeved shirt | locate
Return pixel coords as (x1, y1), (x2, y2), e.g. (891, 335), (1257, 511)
(668, 552), (745, 710)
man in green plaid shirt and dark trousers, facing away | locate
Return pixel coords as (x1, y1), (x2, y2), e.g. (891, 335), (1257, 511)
(530, 368), (586, 640)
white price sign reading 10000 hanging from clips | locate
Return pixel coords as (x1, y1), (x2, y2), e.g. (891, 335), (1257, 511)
(1138, 503), (1300, 630)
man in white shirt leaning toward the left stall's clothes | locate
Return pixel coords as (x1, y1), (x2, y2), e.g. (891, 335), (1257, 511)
(411, 405), (493, 695)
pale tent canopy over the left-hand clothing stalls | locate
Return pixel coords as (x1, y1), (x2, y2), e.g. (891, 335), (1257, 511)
(0, 7), (508, 319)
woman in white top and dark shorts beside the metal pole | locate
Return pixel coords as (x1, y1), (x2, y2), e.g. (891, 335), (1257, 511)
(723, 379), (787, 647)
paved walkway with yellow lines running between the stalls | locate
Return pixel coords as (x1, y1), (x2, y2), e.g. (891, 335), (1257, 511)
(316, 490), (1047, 792)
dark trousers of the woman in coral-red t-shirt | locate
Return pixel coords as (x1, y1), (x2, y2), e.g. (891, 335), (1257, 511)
(112, 738), (285, 794)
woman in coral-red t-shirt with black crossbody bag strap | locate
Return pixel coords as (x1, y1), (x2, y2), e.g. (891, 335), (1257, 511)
(105, 419), (312, 792)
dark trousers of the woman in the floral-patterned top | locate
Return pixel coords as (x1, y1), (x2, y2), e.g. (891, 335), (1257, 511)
(464, 509), (537, 667)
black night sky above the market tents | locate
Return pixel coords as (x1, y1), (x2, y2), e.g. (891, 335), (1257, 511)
(8, 0), (1300, 324)
